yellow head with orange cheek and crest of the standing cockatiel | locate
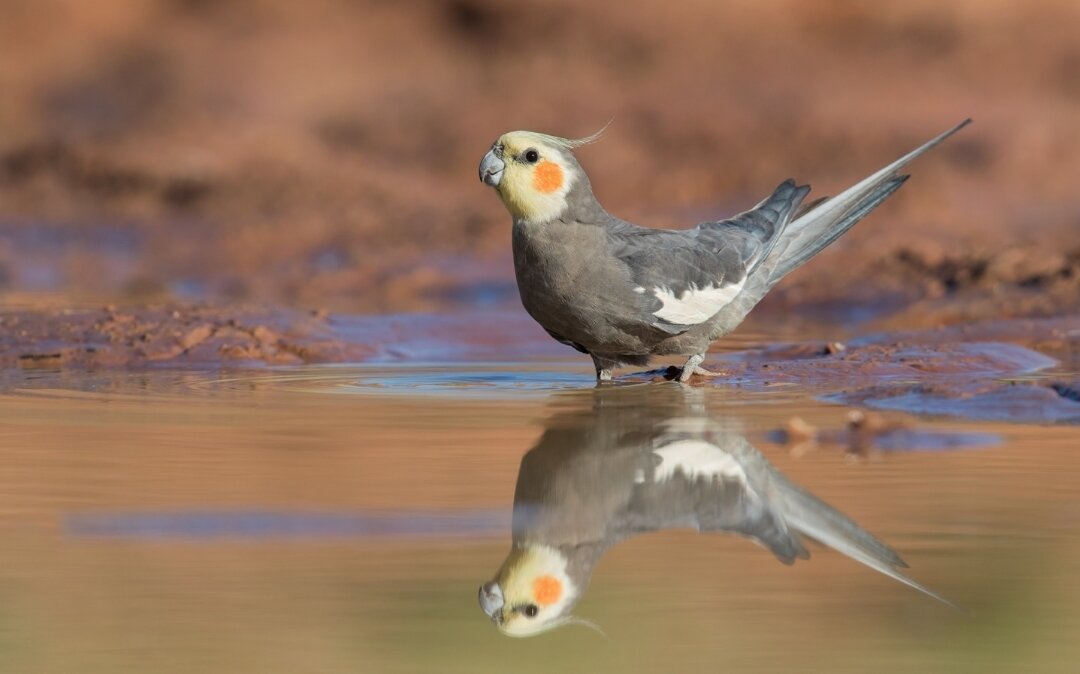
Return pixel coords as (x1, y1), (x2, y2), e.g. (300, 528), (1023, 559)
(480, 129), (604, 224)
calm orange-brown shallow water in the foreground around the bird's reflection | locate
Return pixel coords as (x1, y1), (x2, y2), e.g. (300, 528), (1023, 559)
(0, 361), (1080, 673)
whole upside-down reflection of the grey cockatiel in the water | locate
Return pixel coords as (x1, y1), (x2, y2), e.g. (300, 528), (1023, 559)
(480, 383), (948, 636)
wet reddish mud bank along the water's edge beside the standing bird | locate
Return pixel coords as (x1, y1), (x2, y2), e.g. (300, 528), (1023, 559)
(0, 306), (1080, 423)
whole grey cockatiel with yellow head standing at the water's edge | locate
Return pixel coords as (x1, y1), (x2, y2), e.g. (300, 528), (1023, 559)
(480, 119), (971, 382)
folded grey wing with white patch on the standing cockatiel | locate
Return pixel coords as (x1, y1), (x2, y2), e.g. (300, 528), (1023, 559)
(612, 180), (809, 334)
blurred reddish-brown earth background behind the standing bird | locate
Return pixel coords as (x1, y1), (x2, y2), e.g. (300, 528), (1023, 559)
(0, 0), (1080, 322)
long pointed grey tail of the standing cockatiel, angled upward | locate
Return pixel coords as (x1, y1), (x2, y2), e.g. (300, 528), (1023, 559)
(762, 119), (971, 286)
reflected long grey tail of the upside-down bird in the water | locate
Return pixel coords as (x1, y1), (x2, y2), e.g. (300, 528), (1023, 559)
(781, 473), (962, 611)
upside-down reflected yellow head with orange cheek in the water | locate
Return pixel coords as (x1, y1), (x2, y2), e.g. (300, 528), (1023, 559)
(480, 544), (583, 636)
